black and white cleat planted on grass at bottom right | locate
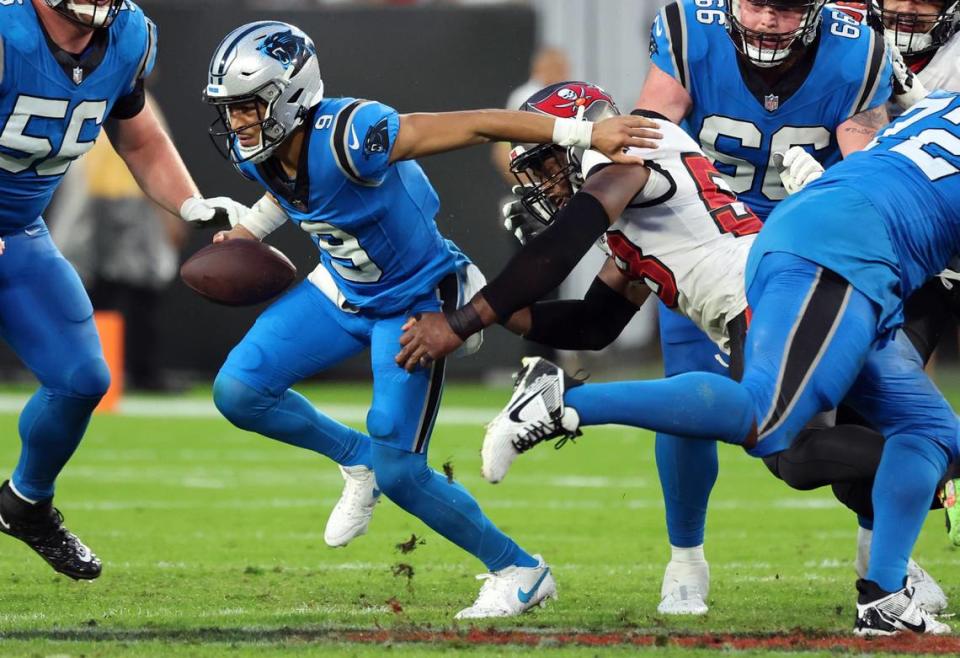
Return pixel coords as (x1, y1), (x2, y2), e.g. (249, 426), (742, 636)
(853, 579), (950, 636)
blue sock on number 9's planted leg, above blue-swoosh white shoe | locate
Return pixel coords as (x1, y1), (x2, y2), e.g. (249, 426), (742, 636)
(373, 442), (537, 571)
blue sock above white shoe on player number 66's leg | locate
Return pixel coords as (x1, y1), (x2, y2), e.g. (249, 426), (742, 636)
(656, 434), (719, 548)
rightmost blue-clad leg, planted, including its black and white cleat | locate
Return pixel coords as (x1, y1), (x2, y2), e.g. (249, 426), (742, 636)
(848, 337), (958, 634)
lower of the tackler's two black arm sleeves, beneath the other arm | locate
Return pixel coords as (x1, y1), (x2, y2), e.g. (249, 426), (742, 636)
(524, 277), (638, 350)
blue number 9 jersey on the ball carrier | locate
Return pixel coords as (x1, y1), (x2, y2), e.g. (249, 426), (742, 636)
(239, 98), (466, 315)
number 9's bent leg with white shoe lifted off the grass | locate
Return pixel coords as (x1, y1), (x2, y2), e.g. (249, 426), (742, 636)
(213, 281), (379, 546)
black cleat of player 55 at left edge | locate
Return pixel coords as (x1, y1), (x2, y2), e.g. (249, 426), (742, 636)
(0, 480), (101, 580)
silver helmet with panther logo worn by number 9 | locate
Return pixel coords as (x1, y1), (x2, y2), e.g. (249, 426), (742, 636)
(203, 21), (323, 163)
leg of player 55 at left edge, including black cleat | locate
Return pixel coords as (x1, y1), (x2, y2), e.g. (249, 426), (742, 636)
(0, 221), (110, 579)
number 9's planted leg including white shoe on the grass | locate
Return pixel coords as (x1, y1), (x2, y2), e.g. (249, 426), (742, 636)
(367, 309), (556, 618)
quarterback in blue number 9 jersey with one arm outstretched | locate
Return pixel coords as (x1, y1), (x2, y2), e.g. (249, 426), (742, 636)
(205, 21), (655, 619)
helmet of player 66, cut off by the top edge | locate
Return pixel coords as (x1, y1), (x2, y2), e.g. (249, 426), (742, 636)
(726, 0), (827, 68)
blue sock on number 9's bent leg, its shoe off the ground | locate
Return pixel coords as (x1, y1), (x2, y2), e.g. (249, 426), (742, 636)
(213, 373), (373, 467)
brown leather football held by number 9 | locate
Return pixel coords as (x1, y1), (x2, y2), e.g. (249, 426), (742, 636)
(180, 240), (297, 306)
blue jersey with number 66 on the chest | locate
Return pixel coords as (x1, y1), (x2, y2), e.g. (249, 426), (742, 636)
(650, 0), (892, 219)
